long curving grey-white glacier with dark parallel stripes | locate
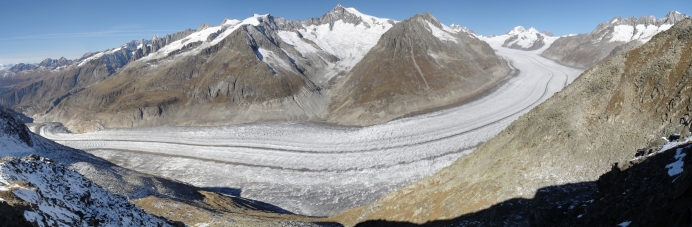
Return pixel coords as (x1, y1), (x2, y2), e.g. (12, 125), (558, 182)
(36, 40), (581, 215)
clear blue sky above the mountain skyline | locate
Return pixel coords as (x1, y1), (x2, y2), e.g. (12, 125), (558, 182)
(0, 0), (692, 64)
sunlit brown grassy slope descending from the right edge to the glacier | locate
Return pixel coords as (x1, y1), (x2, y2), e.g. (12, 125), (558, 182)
(335, 19), (692, 227)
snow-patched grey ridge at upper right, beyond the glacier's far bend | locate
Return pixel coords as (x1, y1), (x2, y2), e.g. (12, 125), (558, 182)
(543, 11), (688, 69)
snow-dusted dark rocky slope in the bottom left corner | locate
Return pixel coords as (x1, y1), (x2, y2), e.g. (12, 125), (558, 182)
(0, 155), (170, 226)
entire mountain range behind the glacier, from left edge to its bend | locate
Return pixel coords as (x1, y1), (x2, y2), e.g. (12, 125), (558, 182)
(0, 5), (509, 132)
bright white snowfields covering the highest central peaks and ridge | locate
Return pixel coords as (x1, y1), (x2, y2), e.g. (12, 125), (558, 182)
(140, 5), (397, 80)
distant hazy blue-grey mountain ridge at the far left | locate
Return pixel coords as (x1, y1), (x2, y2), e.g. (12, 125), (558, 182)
(0, 30), (192, 120)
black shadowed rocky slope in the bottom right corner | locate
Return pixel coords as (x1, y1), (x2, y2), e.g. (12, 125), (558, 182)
(357, 144), (692, 227)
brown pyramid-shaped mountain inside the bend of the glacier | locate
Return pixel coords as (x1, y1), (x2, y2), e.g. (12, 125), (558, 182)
(327, 13), (509, 125)
